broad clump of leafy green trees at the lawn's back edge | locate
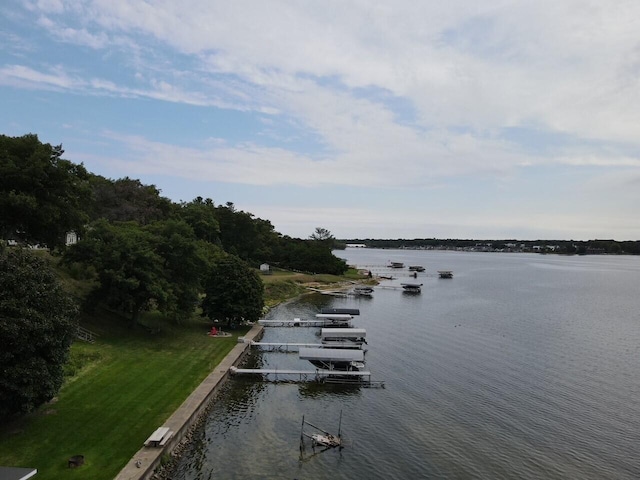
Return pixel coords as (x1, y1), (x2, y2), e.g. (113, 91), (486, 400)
(65, 219), (215, 325)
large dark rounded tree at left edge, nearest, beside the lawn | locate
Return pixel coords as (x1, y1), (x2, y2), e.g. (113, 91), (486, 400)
(0, 250), (78, 418)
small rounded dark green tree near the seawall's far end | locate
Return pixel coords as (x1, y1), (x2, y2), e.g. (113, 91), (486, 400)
(202, 255), (264, 325)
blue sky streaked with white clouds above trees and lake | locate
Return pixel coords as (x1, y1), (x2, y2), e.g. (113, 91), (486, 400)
(0, 0), (640, 241)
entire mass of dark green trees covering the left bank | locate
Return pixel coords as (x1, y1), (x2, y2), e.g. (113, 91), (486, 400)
(0, 134), (347, 417)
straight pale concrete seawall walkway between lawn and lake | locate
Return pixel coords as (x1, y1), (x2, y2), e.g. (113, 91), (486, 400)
(115, 324), (264, 480)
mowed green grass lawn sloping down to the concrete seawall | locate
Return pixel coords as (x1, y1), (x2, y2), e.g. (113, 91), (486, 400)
(0, 317), (247, 480)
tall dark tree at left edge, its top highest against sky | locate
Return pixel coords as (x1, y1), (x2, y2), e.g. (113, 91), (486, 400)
(0, 134), (91, 248)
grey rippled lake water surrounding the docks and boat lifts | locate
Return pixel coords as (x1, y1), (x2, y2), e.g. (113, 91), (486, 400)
(172, 249), (640, 480)
